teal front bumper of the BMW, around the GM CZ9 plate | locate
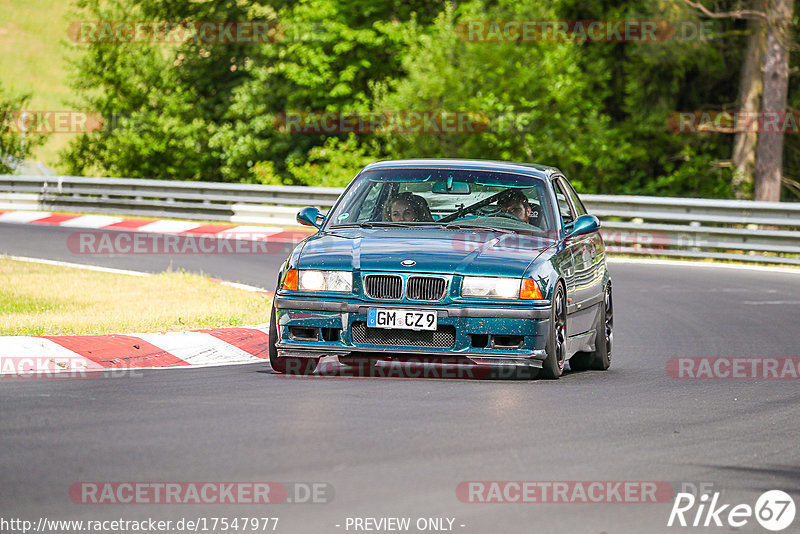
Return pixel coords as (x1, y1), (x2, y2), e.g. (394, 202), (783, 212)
(275, 295), (550, 367)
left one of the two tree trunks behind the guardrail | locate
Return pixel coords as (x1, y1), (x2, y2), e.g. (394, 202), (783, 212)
(731, 0), (767, 198)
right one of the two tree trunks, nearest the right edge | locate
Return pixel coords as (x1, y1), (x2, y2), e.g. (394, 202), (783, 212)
(755, 0), (794, 202)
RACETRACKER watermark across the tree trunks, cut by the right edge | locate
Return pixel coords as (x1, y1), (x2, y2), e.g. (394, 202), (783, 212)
(667, 111), (800, 134)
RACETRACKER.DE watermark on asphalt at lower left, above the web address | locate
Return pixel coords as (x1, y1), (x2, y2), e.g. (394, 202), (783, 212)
(69, 481), (334, 504)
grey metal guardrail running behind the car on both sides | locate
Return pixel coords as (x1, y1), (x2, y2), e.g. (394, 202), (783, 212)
(0, 175), (800, 265)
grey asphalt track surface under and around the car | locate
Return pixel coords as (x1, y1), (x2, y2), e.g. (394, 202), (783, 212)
(0, 220), (800, 533)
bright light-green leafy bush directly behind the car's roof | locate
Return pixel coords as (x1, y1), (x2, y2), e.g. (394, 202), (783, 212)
(379, 3), (627, 191)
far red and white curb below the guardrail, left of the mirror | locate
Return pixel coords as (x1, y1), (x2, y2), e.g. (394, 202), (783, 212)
(0, 210), (311, 242)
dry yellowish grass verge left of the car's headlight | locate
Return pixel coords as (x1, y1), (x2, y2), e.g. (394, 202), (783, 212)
(0, 257), (272, 336)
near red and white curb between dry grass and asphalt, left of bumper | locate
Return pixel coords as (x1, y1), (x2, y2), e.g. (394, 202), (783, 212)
(0, 325), (269, 377)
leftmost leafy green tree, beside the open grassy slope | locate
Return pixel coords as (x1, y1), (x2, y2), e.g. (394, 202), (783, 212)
(63, 0), (264, 181)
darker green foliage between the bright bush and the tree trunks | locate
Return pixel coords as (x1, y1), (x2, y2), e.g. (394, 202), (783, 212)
(557, 0), (746, 197)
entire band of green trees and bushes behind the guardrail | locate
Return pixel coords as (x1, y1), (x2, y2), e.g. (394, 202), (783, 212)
(56, 0), (788, 197)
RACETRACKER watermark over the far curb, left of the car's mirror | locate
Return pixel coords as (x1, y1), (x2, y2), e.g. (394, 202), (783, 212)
(67, 231), (299, 254)
